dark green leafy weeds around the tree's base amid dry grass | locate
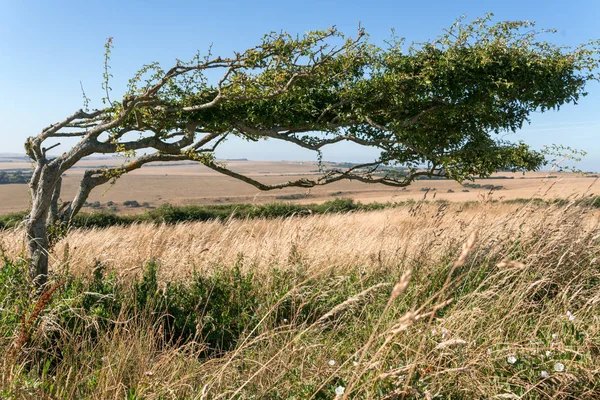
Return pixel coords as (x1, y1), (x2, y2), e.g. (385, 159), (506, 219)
(0, 258), (393, 363)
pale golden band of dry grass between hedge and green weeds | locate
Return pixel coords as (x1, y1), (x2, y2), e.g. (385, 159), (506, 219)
(0, 203), (600, 279)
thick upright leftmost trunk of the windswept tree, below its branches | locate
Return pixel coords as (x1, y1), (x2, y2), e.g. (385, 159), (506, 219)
(25, 164), (60, 287)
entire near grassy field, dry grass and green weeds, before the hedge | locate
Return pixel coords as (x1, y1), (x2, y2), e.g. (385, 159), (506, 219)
(0, 199), (600, 399)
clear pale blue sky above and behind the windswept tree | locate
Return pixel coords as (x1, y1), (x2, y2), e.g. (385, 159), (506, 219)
(0, 0), (600, 170)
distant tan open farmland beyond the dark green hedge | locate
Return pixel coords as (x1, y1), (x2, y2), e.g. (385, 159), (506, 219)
(0, 157), (600, 214)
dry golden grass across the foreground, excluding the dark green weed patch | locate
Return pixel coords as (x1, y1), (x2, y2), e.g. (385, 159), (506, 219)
(0, 198), (600, 399)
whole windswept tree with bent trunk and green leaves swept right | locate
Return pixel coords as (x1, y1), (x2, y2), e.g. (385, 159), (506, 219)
(25, 16), (598, 284)
